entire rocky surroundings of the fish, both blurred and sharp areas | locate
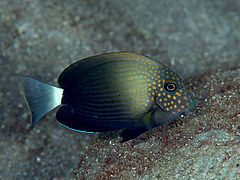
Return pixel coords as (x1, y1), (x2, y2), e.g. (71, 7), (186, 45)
(0, 0), (240, 180)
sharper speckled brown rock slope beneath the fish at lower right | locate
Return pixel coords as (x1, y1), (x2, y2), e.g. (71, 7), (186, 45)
(73, 68), (240, 179)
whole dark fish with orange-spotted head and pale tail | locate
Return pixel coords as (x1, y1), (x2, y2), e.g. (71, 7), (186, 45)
(23, 52), (196, 142)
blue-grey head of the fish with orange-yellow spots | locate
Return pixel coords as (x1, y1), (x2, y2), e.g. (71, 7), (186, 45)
(153, 65), (196, 115)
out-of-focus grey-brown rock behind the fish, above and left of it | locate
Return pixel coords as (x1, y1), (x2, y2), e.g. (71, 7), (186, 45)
(0, 0), (240, 180)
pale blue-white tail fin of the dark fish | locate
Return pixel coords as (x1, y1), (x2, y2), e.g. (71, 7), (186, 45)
(24, 76), (63, 124)
